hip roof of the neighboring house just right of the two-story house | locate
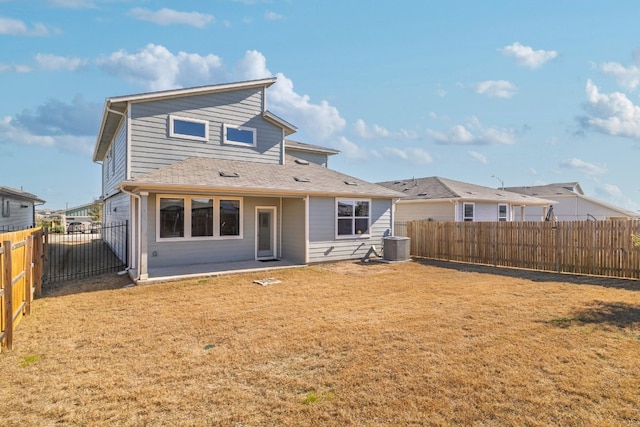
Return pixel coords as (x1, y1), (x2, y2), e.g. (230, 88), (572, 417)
(378, 176), (555, 206)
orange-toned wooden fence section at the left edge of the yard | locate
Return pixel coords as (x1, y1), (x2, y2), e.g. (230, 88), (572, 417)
(0, 227), (43, 350)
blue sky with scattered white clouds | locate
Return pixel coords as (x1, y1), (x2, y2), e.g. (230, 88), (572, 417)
(0, 0), (640, 211)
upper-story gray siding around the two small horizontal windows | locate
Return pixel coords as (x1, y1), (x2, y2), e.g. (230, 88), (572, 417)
(130, 88), (283, 178)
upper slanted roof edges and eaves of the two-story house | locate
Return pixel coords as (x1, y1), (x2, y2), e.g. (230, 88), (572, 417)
(93, 77), (297, 162)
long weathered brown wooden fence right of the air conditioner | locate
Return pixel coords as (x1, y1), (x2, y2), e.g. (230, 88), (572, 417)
(406, 220), (640, 279)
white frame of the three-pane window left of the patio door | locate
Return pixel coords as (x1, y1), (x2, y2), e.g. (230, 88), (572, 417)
(156, 194), (244, 242)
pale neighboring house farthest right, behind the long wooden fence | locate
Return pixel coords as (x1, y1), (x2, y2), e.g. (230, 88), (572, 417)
(507, 182), (639, 221)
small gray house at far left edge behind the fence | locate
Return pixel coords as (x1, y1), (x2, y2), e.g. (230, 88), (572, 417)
(0, 186), (44, 231)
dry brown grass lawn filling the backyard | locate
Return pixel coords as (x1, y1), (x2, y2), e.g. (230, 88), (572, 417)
(0, 262), (640, 426)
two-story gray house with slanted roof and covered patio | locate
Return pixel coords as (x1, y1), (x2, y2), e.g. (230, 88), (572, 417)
(93, 78), (402, 281)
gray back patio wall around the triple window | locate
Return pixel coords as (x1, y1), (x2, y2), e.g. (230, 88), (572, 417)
(147, 194), (280, 268)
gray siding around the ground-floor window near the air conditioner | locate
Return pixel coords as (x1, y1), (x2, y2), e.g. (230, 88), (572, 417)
(309, 197), (391, 262)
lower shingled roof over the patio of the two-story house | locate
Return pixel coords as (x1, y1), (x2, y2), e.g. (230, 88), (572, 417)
(121, 155), (403, 198)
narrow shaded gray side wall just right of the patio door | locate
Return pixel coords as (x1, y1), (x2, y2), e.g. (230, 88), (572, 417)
(282, 199), (305, 263)
